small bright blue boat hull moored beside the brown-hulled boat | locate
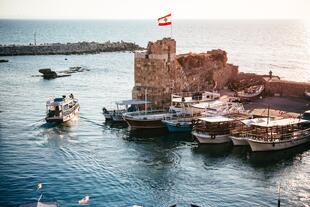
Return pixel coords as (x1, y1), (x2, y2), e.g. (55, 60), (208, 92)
(162, 119), (193, 132)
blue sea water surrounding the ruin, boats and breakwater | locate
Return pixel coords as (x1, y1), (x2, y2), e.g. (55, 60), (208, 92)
(0, 20), (310, 207)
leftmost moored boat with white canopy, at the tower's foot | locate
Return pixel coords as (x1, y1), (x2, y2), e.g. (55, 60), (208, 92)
(102, 100), (149, 122)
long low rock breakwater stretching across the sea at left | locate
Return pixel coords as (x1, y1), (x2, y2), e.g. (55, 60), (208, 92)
(0, 41), (143, 56)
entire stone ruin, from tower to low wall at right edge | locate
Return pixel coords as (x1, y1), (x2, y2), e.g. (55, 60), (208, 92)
(132, 38), (310, 106)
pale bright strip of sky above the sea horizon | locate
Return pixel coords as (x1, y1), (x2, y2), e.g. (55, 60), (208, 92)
(0, 0), (310, 20)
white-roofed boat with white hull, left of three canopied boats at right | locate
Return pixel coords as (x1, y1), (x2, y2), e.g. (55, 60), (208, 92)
(192, 116), (235, 144)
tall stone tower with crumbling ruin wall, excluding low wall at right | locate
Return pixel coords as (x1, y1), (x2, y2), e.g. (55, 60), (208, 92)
(132, 38), (238, 106)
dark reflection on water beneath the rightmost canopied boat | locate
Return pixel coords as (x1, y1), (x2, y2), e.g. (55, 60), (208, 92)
(249, 143), (310, 167)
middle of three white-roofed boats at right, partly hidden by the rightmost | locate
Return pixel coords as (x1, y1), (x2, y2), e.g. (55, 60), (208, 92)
(230, 118), (270, 146)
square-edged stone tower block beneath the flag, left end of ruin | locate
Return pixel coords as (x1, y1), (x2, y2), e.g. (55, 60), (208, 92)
(132, 38), (184, 106)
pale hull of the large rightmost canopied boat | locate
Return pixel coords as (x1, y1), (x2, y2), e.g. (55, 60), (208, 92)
(248, 136), (310, 152)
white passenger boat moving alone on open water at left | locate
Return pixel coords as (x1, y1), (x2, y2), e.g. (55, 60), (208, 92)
(45, 94), (80, 123)
